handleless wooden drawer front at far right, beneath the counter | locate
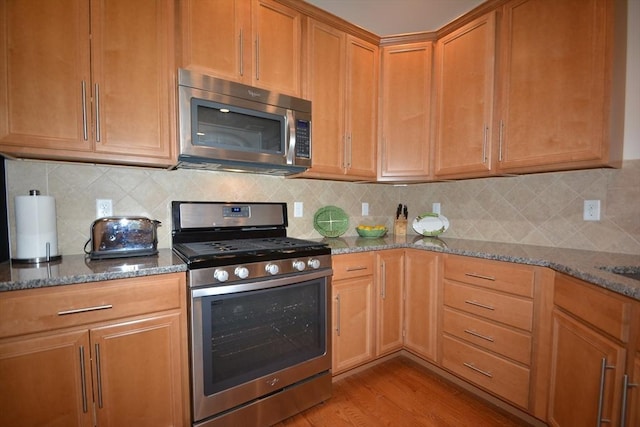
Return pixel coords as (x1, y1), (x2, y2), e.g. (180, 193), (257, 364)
(553, 274), (632, 342)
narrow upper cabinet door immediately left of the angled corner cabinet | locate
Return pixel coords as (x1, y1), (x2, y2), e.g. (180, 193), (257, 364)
(345, 36), (378, 178)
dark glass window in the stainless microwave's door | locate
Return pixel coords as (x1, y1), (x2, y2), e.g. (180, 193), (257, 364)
(191, 99), (285, 155)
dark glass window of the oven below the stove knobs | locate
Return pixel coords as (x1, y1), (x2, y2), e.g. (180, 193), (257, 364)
(202, 278), (327, 395)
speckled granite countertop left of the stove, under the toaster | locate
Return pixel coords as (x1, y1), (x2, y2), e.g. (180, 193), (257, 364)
(0, 249), (187, 292)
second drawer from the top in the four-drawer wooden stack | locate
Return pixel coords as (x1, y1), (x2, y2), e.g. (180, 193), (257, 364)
(444, 280), (533, 331)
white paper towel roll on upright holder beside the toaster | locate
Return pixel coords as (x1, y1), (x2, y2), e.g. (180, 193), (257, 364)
(15, 190), (58, 261)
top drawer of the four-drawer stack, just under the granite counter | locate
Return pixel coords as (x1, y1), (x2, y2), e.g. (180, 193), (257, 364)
(444, 255), (535, 298)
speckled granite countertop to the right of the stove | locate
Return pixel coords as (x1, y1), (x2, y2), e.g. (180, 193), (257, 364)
(320, 235), (640, 300)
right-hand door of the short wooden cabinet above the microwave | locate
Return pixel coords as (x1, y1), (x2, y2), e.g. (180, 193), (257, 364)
(252, 0), (302, 96)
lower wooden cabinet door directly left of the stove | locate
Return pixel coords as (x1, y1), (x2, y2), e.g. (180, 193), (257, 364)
(91, 313), (186, 427)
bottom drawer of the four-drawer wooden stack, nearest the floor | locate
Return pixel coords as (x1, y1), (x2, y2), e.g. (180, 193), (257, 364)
(442, 336), (529, 408)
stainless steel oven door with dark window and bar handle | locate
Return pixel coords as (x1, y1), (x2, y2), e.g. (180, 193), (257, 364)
(191, 270), (331, 422)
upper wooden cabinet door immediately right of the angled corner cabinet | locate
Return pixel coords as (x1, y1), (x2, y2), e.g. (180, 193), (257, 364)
(435, 12), (495, 177)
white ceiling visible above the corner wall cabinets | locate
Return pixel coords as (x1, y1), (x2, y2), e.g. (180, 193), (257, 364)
(305, 0), (485, 36)
